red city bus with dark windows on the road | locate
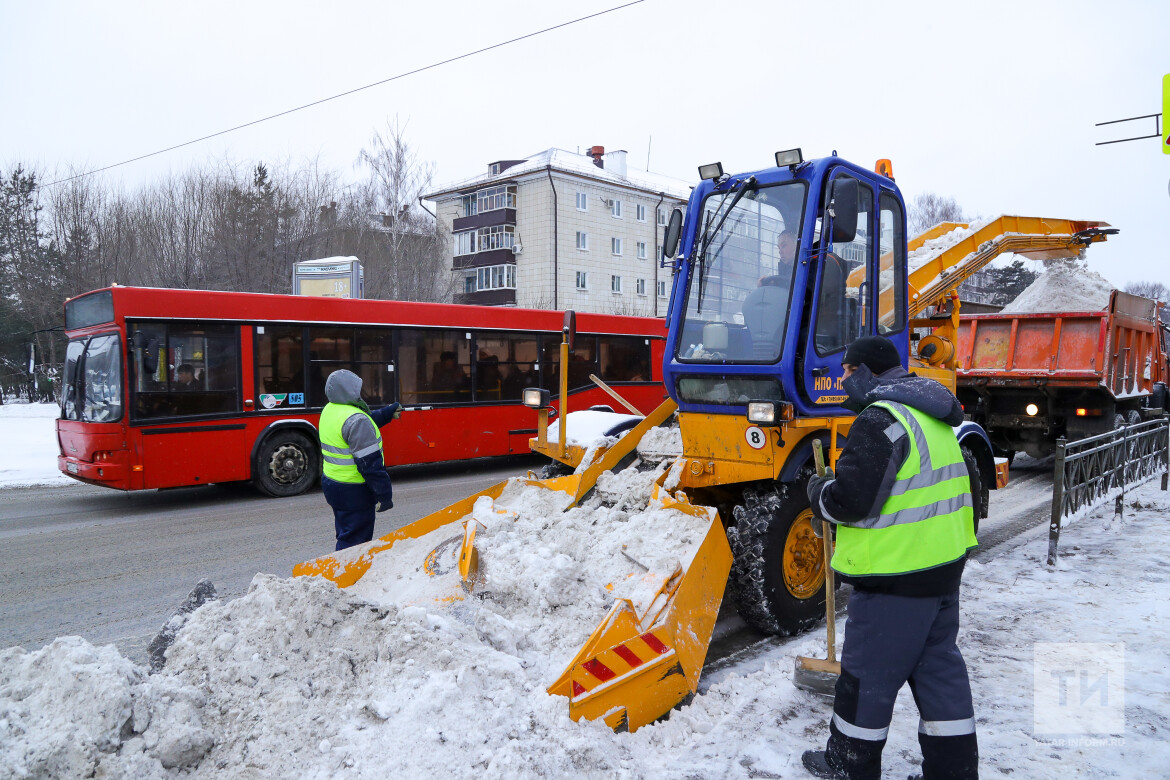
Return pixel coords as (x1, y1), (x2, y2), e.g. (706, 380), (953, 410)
(57, 287), (666, 496)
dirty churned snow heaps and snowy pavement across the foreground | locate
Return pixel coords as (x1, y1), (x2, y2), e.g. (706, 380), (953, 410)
(0, 428), (1170, 778)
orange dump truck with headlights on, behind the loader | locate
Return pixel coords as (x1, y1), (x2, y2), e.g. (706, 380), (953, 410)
(956, 290), (1170, 457)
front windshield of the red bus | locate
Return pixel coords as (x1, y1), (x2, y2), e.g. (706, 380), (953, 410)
(61, 333), (122, 422)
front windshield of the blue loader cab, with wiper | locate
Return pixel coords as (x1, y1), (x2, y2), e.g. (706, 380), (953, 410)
(677, 181), (806, 363)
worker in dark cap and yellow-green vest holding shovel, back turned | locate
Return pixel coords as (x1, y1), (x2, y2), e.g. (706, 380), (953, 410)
(803, 336), (979, 780)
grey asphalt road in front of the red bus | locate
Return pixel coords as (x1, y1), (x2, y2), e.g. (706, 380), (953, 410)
(0, 456), (538, 663)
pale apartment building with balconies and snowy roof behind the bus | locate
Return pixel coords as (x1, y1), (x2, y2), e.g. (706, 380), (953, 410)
(422, 146), (691, 317)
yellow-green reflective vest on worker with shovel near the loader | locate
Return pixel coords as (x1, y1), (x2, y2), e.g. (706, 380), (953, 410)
(832, 401), (978, 577)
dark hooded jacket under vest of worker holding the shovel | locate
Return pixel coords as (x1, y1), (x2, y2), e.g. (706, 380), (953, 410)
(808, 366), (965, 596)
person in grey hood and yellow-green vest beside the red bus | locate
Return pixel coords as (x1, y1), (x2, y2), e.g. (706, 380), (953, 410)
(318, 368), (402, 550)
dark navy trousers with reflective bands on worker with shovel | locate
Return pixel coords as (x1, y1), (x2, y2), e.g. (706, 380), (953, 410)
(825, 591), (979, 780)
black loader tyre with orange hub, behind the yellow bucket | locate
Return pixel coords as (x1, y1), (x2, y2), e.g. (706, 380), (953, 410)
(728, 479), (825, 636)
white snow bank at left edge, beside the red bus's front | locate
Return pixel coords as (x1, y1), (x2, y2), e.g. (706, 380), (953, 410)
(0, 402), (78, 488)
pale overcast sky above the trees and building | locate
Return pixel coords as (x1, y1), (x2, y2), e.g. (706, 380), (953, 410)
(0, 0), (1170, 285)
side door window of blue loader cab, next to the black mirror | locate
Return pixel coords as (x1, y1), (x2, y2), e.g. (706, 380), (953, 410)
(817, 174), (874, 357)
